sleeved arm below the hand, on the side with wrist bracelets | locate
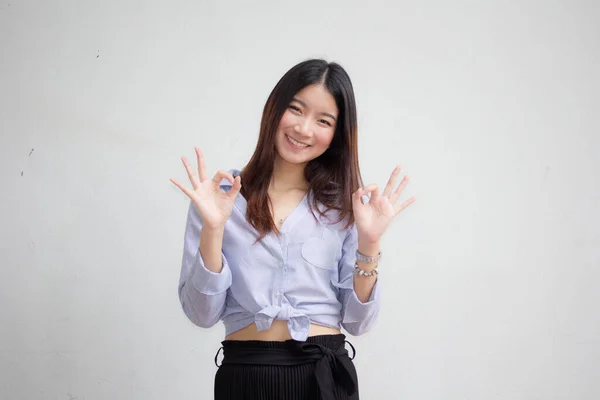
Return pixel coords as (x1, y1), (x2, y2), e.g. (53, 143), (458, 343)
(336, 225), (380, 336)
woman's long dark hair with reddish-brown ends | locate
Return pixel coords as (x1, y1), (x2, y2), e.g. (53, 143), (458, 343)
(241, 59), (362, 240)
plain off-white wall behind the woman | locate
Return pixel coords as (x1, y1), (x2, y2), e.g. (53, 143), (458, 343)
(0, 0), (600, 400)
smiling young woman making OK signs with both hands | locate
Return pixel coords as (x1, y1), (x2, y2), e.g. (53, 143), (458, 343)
(171, 60), (414, 400)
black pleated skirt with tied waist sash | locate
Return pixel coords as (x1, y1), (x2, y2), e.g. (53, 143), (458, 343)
(214, 334), (359, 400)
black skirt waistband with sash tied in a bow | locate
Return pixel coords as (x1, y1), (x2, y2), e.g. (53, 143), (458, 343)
(215, 334), (358, 400)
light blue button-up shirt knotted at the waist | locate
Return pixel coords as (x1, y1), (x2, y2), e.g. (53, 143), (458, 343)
(179, 170), (379, 341)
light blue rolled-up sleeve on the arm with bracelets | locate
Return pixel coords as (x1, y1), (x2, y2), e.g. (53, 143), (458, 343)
(335, 225), (380, 336)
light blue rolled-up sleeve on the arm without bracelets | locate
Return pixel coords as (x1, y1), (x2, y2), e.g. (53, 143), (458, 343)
(179, 201), (231, 328)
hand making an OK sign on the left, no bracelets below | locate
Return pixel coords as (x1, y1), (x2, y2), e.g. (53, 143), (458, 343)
(170, 146), (242, 229)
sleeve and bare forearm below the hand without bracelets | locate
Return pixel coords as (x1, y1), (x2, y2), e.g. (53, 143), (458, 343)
(179, 202), (231, 328)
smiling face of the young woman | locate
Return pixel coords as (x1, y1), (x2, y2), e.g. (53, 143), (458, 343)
(275, 84), (338, 164)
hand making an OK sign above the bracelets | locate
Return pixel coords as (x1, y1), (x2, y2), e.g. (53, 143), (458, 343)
(352, 166), (416, 243)
